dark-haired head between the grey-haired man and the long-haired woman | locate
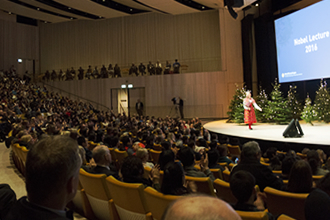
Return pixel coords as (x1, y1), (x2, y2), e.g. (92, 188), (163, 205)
(120, 156), (144, 183)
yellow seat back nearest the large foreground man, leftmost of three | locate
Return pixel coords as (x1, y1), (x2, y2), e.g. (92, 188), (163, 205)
(79, 169), (114, 219)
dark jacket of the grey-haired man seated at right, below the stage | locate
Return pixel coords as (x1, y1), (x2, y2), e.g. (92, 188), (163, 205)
(231, 159), (283, 192)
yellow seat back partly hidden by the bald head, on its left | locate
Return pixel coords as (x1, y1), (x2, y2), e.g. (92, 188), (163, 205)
(144, 187), (181, 220)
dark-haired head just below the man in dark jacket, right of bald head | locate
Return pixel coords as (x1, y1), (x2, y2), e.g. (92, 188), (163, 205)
(230, 170), (256, 203)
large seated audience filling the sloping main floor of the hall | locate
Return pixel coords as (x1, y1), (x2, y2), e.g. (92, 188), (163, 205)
(0, 71), (330, 219)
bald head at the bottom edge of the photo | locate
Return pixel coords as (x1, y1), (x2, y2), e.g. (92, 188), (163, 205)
(162, 195), (241, 220)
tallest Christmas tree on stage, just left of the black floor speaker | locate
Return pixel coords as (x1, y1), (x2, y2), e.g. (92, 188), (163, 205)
(267, 79), (290, 124)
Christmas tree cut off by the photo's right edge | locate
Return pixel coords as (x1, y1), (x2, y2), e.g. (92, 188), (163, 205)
(314, 80), (330, 123)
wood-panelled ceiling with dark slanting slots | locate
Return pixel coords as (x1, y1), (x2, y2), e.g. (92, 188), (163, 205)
(0, 0), (317, 23)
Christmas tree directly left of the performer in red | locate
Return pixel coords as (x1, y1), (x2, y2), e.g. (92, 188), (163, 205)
(227, 85), (246, 123)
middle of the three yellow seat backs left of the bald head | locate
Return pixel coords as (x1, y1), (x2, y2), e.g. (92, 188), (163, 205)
(106, 176), (148, 220)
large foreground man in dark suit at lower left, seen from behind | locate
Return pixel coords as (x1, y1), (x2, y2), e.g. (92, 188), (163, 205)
(6, 136), (81, 220)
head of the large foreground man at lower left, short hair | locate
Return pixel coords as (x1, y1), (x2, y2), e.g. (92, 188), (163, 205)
(26, 136), (81, 210)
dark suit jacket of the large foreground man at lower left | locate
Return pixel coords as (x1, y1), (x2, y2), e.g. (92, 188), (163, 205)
(5, 196), (73, 220)
